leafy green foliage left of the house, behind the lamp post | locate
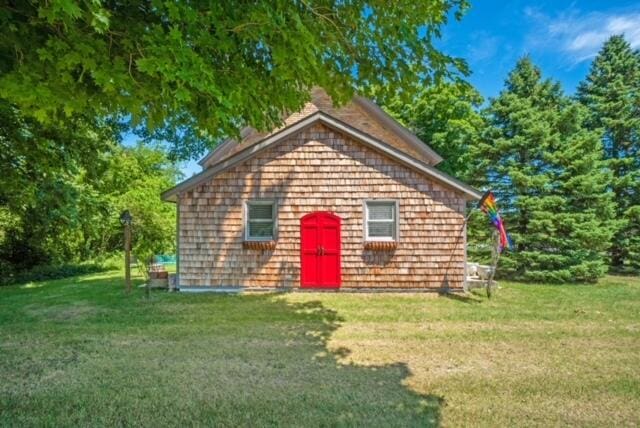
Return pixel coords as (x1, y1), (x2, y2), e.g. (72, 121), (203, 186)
(0, 103), (177, 280)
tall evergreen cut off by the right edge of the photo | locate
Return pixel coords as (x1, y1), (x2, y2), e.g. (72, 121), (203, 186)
(578, 36), (640, 270)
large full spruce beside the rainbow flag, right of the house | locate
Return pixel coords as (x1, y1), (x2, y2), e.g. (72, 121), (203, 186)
(471, 58), (613, 282)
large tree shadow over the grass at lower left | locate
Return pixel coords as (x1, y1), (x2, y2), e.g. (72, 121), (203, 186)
(0, 272), (443, 426)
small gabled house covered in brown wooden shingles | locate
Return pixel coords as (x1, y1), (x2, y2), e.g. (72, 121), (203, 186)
(162, 89), (481, 291)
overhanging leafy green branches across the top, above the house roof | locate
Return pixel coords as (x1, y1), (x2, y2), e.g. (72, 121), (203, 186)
(0, 0), (467, 158)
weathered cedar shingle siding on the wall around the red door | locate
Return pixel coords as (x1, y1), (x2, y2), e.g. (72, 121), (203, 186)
(178, 123), (466, 289)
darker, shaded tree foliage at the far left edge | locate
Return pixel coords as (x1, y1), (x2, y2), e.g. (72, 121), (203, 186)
(0, 100), (115, 269)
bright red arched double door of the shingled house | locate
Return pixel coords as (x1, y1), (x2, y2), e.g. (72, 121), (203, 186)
(300, 211), (342, 288)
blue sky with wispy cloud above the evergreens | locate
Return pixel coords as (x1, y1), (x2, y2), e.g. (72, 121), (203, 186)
(125, 0), (640, 177)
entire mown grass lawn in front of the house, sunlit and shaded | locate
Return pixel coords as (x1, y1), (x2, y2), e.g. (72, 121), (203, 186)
(0, 272), (640, 426)
